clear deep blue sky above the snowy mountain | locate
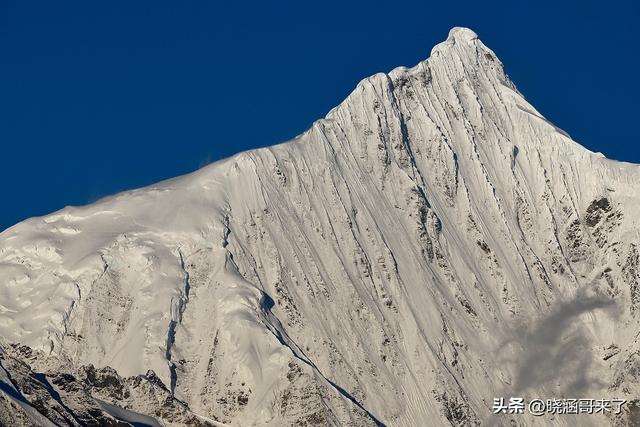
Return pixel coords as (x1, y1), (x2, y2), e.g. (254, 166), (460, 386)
(0, 0), (640, 229)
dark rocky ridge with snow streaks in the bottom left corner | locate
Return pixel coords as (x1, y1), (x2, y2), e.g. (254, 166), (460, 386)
(0, 346), (215, 426)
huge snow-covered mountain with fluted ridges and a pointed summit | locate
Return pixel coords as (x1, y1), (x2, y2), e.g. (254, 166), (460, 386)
(0, 28), (640, 426)
